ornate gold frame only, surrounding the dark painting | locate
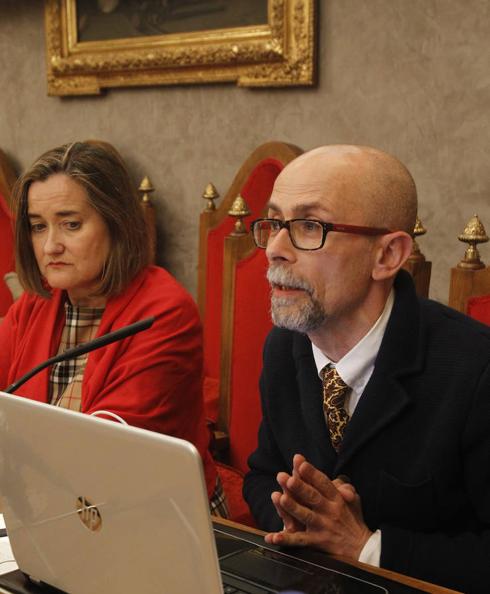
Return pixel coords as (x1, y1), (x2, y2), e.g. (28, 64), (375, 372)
(45, 0), (316, 95)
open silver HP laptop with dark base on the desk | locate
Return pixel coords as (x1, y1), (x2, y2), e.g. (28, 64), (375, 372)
(0, 392), (422, 594)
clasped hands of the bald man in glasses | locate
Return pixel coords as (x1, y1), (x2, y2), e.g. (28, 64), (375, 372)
(265, 454), (372, 560)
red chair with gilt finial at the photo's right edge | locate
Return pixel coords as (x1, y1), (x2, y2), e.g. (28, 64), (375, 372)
(449, 215), (490, 325)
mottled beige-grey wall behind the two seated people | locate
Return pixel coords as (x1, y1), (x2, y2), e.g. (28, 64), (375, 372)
(0, 0), (490, 301)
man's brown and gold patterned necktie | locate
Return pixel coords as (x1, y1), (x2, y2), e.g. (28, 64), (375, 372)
(322, 365), (349, 452)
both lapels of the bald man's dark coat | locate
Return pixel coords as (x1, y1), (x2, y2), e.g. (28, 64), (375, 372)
(293, 270), (425, 478)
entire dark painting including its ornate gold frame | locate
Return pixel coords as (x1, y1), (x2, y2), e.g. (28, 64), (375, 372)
(45, 0), (316, 95)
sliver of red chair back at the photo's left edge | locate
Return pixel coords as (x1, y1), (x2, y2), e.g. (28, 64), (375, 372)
(0, 149), (16, 318)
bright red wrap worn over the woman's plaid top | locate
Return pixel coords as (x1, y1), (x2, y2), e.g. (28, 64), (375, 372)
(0, 266), (216, 496)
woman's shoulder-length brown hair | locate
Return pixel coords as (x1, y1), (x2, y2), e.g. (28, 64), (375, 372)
(13, 140), (149, 297)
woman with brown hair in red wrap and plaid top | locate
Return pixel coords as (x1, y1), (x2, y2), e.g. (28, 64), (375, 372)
(0, 141), (226, 515)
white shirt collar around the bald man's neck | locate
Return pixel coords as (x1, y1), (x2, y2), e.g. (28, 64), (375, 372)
(311, 289), (395, 404)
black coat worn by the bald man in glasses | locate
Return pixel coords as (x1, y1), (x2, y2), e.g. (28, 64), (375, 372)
(244, 272), (490, 592)
